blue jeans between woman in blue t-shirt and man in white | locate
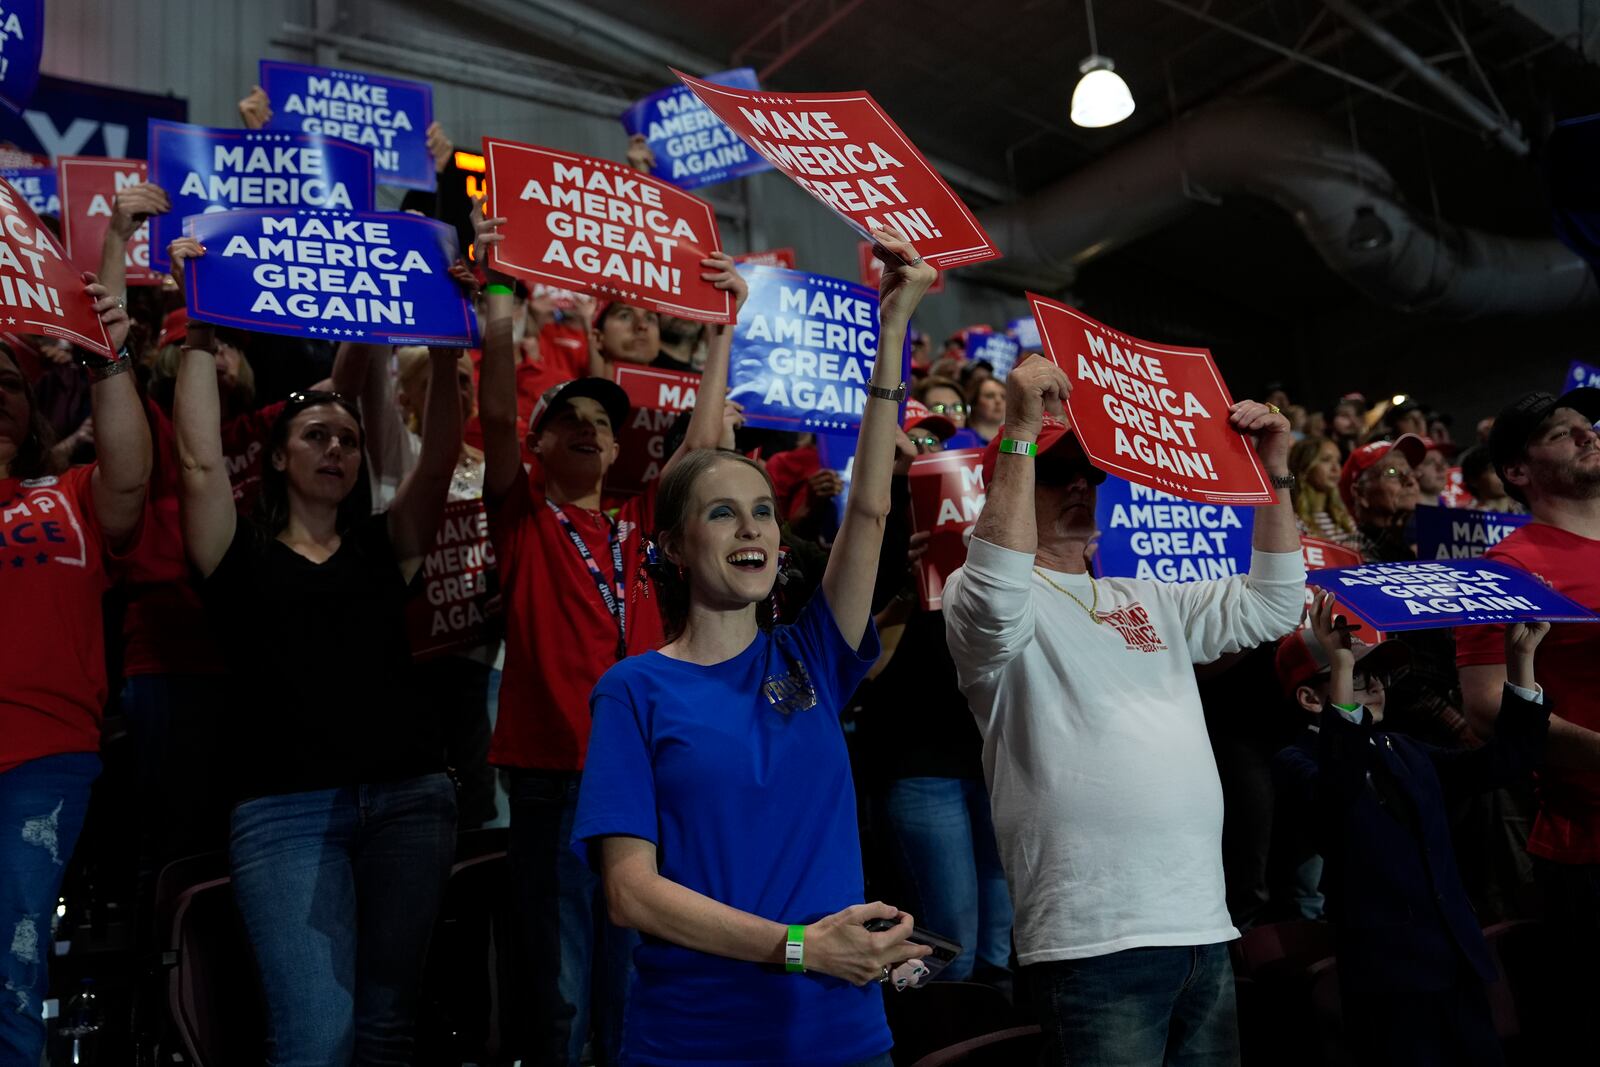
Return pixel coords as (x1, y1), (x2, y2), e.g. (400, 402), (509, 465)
(883, 777), (1011, 982)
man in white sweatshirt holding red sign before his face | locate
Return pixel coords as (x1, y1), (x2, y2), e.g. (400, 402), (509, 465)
(944, 357), (1306, 1067)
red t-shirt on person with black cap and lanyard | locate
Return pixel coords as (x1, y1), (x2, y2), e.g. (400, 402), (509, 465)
(486, 478), (664, 771)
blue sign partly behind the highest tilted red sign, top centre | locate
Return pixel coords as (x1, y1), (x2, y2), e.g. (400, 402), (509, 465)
(622, 67), (773, 189)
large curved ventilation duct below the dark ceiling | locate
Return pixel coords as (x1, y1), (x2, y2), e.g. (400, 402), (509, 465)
(973, 101), (1600, 318)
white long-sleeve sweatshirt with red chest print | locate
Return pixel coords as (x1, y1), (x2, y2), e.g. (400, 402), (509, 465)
(944, 537), (1306, 965)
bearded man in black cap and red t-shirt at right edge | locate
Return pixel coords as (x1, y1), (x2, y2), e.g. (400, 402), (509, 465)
(1456, 389), (1600, 1062)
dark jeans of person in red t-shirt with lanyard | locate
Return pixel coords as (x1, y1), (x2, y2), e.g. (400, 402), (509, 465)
(510, 771), (638, 1067)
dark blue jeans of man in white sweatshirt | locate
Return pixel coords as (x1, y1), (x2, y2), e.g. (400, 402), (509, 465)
(1022, 944), (1238, 1067)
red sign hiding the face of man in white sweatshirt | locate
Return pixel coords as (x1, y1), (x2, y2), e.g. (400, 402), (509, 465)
(1027, 293), (1277, 504)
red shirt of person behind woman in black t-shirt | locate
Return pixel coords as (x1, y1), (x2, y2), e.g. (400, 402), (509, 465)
(118, 400), (283, 677)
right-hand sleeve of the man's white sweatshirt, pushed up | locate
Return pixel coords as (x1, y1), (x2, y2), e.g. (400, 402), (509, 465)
(1162, 550), (1306, 664)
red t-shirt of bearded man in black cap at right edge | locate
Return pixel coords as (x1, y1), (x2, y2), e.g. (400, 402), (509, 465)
(1456, 523), (1600, 864)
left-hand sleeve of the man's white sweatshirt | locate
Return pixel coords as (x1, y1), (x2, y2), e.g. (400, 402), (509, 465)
(944, 537), (1034, 686)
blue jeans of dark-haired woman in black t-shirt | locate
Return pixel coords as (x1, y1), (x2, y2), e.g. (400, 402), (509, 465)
(230, 774), (456, 1067)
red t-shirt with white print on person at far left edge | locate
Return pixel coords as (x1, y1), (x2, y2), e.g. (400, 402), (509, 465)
(0, 464), (110, 773)
